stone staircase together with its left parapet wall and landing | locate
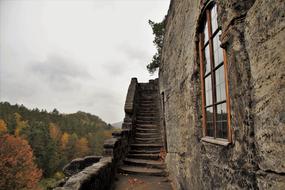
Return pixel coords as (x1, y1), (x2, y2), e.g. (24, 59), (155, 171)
(55, 78), (172, 190)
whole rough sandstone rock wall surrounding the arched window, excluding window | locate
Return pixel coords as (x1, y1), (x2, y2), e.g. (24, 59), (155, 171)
(159, 0), (285, 189)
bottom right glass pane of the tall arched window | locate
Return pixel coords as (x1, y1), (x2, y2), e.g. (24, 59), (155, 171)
(216, 103), (228, 138)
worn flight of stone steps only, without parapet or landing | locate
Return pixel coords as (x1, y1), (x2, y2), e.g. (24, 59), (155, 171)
(118, 83), (167, 176)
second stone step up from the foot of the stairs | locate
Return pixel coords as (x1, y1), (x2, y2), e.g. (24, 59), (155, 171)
(124, 158), (165, 169)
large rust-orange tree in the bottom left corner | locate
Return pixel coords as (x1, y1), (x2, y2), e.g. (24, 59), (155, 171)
(0, 134), (42, 189)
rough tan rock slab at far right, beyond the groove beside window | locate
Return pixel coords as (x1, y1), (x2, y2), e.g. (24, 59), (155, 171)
(245, 0), (285, 189)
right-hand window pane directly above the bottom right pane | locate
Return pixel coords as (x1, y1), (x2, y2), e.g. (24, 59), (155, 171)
(215, 65), (226, 102)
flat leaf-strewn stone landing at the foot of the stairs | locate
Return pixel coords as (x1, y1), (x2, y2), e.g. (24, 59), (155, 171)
(113, 174), (173, 190)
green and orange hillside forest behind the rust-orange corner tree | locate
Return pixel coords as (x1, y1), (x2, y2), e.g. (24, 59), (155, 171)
(0, 102), (114, 190)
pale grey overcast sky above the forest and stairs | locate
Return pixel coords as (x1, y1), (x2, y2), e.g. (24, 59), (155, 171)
(0, 0), (170, 123)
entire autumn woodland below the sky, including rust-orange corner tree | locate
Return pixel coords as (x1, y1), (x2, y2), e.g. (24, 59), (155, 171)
(0, 102), (114, 189)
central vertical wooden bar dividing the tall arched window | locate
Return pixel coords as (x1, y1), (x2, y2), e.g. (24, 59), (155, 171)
(206, 10), (217, 138)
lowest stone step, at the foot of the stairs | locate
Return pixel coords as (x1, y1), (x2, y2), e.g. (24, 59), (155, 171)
(118, 165), (167, 176)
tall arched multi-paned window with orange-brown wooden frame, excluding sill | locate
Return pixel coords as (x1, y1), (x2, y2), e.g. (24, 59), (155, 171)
(199, 3), (231, 141)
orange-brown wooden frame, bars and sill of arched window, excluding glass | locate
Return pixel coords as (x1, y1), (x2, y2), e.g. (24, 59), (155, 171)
(198, 3), (232, 145)
